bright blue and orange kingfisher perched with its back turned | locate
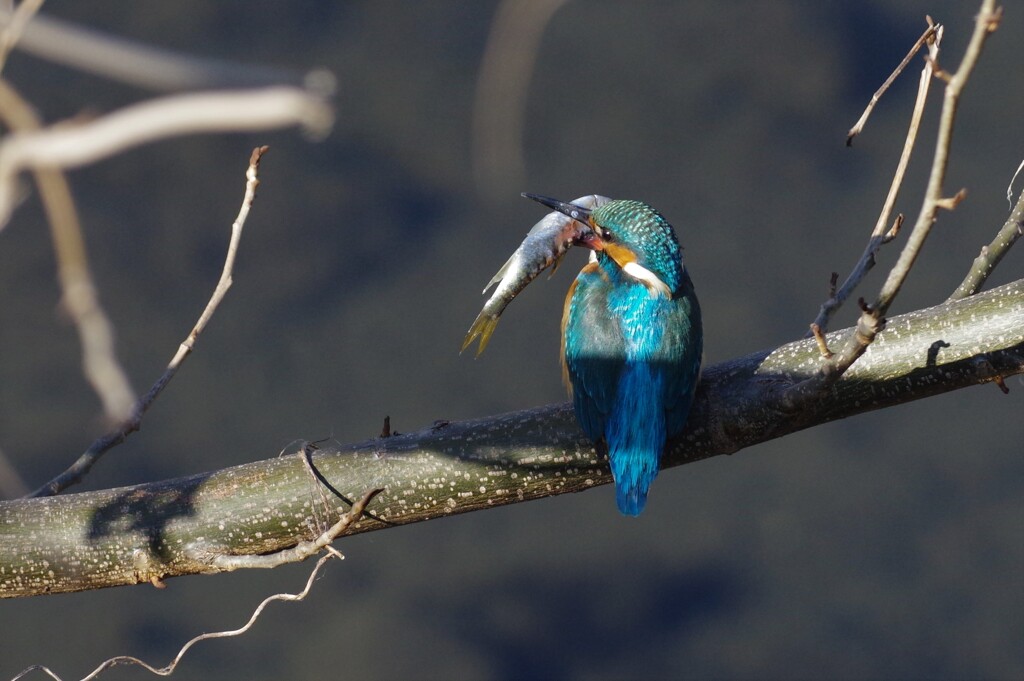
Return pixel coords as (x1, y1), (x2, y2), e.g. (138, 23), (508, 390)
(523, 194), (703, 516)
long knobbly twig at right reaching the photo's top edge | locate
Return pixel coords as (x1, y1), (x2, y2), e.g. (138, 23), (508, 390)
(781, 0), (1001, 409)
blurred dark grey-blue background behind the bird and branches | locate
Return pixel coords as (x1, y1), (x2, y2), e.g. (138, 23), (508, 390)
(0, 0), (1024, 679)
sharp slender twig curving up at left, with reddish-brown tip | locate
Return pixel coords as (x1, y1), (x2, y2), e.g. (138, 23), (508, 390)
(31, 146), (267, 497)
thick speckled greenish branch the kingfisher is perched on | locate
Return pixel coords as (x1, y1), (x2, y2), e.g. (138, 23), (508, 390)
(0, 280), (1024, 597)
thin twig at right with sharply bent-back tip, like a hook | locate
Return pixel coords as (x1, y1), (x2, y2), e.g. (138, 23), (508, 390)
(813, 23), (943, 330)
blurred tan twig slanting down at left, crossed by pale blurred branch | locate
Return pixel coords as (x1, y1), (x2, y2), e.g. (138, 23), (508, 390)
(0, 79), (135, 423)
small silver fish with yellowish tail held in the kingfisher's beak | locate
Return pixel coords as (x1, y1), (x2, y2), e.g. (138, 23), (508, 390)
(460, 194), (611, 356)
